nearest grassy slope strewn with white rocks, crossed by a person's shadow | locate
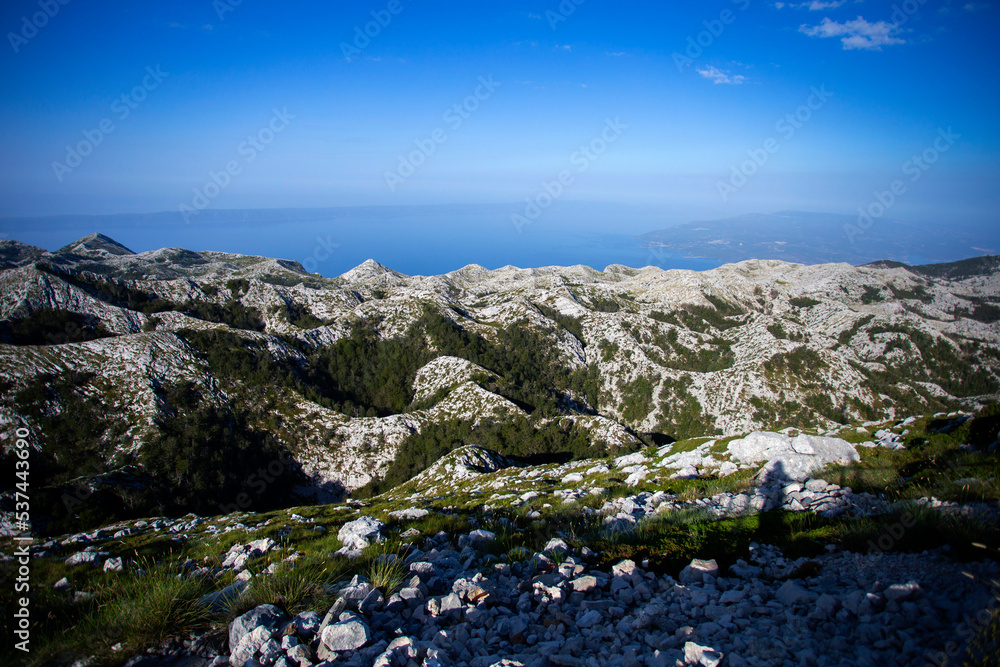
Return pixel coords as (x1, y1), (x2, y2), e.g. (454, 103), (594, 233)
(0, 406), (1000, 667)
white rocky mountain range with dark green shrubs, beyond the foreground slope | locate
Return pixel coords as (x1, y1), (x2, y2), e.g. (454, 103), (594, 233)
(0, 232), (1000, 536)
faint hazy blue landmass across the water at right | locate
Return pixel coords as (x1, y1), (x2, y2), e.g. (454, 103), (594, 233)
(640, 211), (997, 264)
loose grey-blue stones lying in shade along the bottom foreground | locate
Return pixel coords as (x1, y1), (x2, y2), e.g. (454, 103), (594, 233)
(113, 517), (1000, 667)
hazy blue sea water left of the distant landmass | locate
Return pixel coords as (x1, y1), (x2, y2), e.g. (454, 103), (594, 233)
(0, 203), (719, 277)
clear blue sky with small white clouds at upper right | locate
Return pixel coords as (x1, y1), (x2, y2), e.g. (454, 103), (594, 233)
(0, 0), (1000, 227)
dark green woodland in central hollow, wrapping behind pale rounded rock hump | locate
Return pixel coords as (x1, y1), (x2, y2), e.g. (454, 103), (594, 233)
(179, 309), (599, 416)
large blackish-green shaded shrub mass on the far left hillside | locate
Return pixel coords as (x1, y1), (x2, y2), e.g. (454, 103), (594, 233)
(2, 372), (301, 534)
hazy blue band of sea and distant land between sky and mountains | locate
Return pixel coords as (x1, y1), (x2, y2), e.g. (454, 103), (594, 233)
(0, 202), (1000, 277)
